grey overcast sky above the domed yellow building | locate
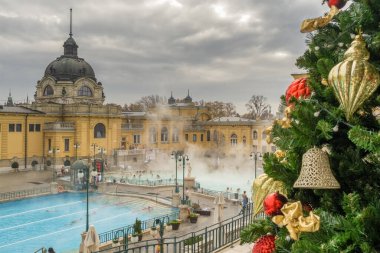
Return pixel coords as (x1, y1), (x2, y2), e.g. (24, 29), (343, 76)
(0, 0), (328, 113)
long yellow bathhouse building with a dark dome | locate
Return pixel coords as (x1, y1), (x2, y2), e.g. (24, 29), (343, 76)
(0, 29), (275, 170)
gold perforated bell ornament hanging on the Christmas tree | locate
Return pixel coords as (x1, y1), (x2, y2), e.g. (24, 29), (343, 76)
(293, 147), (340, 189)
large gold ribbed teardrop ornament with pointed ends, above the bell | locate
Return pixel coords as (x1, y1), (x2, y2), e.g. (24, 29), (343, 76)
(328, 34), (380, 121)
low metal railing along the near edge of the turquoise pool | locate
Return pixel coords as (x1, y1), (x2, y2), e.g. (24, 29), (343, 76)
(99, 211), (179, 243)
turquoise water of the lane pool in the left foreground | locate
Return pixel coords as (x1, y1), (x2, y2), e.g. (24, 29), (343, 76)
(0, 193), (174, 253)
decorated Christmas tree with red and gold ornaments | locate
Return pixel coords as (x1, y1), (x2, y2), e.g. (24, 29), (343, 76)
(241, 0), (380, 252)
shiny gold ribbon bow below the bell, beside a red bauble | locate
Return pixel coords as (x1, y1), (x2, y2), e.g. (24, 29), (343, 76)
(272, 201), (320, 240)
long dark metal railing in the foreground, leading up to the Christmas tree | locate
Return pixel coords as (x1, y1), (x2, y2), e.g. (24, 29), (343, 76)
(97, 203), (265, 253)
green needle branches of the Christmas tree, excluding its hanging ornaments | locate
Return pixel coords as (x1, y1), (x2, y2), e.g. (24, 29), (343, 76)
(242, 0), (380, 252)
